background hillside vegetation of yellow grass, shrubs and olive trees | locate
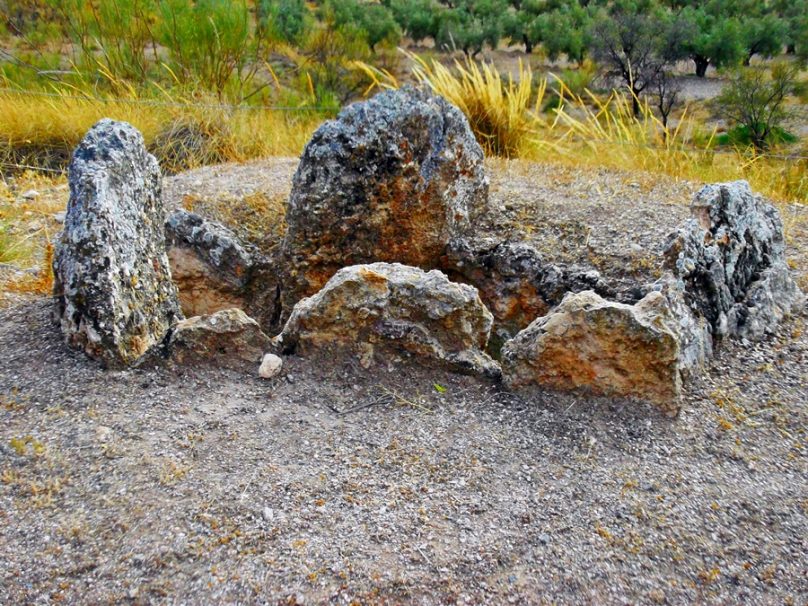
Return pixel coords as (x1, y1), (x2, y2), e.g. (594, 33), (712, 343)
(0, 0), (808, 296)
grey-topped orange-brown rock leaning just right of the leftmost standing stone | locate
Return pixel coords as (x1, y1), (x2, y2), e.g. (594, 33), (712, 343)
(166, 210), (253, 316)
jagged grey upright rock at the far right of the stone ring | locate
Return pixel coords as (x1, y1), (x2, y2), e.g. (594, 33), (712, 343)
(665, 181), (804, 338)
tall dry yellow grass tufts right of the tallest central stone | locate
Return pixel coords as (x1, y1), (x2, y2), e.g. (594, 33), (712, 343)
(360, 55), (808, 207)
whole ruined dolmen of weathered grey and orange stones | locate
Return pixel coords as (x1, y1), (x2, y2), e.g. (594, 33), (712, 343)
(53, 87), (805, 416)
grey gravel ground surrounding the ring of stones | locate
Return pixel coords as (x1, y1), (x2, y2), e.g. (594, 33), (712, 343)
(0, 159), (808, 604)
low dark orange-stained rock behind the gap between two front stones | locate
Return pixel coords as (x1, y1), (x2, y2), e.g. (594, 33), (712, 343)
(444, 239), (615, 350)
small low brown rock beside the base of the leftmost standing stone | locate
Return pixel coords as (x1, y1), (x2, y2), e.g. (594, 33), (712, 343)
(168, 309), (271, 373)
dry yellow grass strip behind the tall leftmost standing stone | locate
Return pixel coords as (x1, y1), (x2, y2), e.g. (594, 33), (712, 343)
(0, 91), (323, 172)
